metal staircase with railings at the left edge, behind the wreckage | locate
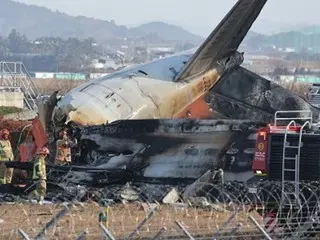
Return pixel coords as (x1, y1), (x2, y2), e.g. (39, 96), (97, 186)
(0, 62), (40, 111)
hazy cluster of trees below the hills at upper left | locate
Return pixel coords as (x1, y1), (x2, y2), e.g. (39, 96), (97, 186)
(0, 29), (102, 71)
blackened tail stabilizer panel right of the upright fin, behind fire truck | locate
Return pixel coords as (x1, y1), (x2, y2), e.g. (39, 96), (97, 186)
(206, 67), (319, 122)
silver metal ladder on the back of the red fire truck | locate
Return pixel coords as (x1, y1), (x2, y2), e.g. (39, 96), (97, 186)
(281, 120), (311, 204)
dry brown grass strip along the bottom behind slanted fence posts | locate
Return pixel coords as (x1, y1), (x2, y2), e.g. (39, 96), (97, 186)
(0, 203), (257, 239)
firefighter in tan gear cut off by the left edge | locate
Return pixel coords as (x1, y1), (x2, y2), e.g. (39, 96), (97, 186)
(0, 129), (14, 184)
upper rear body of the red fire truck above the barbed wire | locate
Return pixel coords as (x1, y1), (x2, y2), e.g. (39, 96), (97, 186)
(252, 111), (320, 195)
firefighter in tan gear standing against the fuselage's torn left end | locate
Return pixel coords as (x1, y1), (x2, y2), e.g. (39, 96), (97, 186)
(55, 130), (73, 166)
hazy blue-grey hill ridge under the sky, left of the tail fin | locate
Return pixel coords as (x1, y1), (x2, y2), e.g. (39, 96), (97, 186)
(0, 0), (202, 44)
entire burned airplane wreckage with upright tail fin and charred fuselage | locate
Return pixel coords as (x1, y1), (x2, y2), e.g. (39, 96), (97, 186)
(6, 0), (319, 202)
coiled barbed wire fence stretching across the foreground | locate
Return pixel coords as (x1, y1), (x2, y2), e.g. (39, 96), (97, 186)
(0, 181), (320, 239)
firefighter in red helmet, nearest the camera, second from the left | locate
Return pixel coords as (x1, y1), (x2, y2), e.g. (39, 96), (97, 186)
(32, 147), (49, 205)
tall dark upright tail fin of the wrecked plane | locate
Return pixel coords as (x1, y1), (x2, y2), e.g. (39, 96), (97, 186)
(174, 0), (267, 81)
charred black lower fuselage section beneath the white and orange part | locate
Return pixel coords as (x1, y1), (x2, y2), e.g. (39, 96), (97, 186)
(44, 119), (264, 185)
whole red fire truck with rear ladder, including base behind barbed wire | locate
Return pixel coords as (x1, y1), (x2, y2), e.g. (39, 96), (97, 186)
(252, 111), (320, 239)
